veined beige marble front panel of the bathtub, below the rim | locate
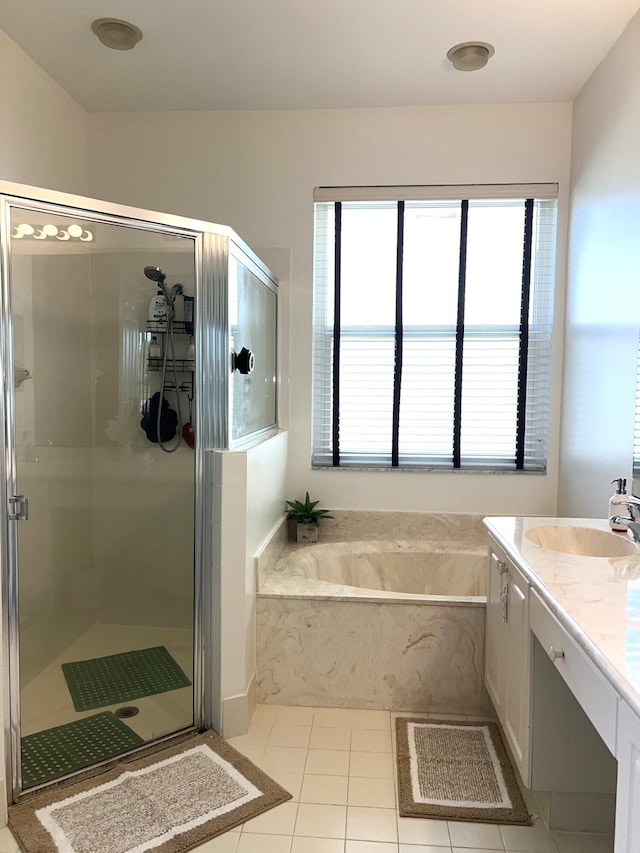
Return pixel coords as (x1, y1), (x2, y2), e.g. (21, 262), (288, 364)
(257, 598), (491, 715)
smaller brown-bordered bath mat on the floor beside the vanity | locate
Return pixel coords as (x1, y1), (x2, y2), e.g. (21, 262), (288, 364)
(396, 717), (531, 825)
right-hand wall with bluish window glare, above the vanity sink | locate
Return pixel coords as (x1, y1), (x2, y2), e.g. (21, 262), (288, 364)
(559, 14), (640, 517)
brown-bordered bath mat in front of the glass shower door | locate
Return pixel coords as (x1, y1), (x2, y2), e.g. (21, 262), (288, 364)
(9, 732), (291, 853)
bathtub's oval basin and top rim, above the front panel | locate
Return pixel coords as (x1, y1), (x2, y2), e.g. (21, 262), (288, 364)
(259, 540), (486, 604)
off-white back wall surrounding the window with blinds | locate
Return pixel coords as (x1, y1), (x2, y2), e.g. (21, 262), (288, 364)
(89, 104), (571, 514)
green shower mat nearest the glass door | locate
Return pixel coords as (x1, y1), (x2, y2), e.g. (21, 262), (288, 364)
(22, 711), (144, 788)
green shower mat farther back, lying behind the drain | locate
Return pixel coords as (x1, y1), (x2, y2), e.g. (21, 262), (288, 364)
(62, 646), (191, 711)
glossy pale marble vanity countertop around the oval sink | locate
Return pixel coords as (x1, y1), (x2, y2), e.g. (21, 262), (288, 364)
(484, 517), (640, 716)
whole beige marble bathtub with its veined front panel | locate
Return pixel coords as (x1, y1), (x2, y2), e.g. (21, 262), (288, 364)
(256, 520), (491, 715)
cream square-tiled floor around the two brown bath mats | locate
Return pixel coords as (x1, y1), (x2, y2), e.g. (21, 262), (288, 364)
(0, 705), (613, 853)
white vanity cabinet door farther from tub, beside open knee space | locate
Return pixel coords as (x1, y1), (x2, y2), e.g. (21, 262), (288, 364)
(503, 565), (531, 783)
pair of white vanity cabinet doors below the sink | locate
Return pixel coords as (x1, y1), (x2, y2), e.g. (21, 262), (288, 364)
(485, 539), (531, 786)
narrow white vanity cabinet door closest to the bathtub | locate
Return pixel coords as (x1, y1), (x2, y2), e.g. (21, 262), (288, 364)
(484, 546), (507, 721)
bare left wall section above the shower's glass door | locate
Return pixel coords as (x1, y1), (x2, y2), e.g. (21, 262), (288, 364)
(0, 30), (89, 195)
